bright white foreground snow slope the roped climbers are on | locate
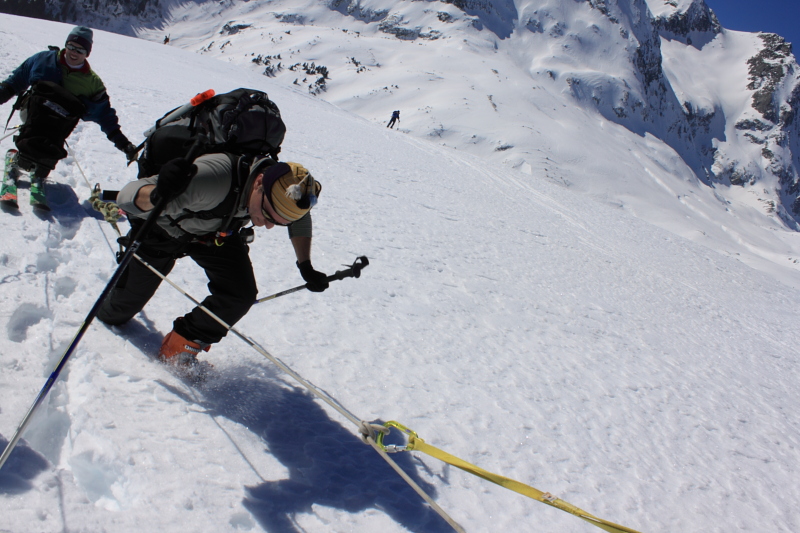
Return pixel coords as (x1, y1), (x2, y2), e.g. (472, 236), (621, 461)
(0, 15), (800, 533)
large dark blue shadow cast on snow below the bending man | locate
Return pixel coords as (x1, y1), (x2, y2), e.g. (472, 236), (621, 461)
(114, 313), (452, 533)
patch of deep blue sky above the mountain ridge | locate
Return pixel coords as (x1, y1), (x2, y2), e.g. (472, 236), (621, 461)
(706, 0), (800, 48)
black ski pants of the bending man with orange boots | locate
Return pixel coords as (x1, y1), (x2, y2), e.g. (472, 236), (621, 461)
(97, 235), (258, 344)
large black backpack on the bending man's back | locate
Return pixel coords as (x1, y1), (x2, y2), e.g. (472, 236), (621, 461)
(139, 89), (286, 178)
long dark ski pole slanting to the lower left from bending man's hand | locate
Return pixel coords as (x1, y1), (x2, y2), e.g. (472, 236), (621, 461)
(0, 135), (206, 469)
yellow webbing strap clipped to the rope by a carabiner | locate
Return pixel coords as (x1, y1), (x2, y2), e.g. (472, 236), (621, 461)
(377, 421), (639, 533)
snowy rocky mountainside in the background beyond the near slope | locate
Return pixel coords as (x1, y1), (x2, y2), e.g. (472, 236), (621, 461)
(126, 0), (800, 287)
